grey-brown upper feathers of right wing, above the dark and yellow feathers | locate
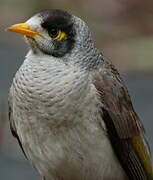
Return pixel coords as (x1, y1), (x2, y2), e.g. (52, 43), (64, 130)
(91, 60), (144, 138)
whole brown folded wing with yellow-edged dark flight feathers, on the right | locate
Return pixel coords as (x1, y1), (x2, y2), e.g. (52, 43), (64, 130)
(92, 61), (153, 180)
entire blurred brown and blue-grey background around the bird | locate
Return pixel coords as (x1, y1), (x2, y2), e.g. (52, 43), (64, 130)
(0, 0), (153, 180)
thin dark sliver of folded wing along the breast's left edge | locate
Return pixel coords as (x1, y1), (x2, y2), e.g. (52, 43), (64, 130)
(8, 90), (27, 158)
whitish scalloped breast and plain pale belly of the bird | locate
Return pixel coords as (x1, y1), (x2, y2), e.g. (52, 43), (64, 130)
(11, 52), (124, 180)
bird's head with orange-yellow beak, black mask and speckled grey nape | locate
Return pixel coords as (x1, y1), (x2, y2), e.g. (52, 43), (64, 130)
(7, 10), (102, 69)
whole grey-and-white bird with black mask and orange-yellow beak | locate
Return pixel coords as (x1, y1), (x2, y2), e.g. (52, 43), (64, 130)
(7, 9), (153, 180)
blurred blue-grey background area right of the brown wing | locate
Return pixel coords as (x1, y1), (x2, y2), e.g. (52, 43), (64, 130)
(124, 73), (153, 148)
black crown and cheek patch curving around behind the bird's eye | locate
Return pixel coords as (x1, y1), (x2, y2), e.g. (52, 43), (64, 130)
(35, 10), (75, 57)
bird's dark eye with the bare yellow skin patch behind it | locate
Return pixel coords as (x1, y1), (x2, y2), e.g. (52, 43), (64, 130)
(48, 28), (67, 41)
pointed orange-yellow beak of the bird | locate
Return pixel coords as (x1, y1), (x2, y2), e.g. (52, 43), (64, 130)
(6, 23), (42, 38)
